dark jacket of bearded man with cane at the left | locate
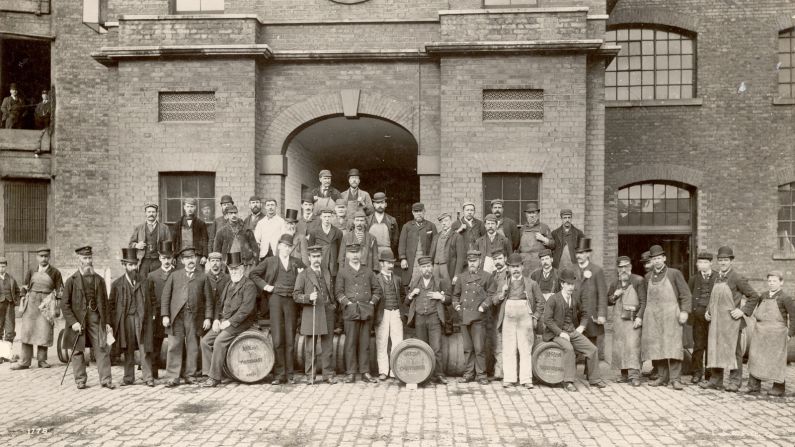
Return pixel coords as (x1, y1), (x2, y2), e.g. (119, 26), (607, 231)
(63, 270), (112, 351)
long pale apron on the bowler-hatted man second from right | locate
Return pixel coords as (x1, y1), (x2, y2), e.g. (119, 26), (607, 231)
(707, 282), (742, 370)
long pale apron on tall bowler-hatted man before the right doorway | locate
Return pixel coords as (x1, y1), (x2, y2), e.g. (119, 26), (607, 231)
(641, 275), (682, 360)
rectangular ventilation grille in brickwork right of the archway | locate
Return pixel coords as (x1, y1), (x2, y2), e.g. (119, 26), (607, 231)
(483, 89), (544, 121)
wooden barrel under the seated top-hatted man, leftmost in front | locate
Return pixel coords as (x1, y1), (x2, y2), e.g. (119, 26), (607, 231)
(224, 329), (274, 383)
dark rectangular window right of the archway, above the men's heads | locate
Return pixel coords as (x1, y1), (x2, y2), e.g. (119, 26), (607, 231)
(483, 173), (541, 224)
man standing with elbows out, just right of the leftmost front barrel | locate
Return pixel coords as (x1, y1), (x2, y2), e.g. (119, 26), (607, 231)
(249, 234), (304, 385)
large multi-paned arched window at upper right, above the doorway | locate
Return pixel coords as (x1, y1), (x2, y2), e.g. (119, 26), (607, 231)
(605, 28), (696, 101)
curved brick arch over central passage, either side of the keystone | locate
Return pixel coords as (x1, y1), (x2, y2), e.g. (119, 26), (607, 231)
(263, 91), (419, 155)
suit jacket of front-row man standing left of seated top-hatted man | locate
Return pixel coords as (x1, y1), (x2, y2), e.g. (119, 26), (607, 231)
(160, 268), (214, 335)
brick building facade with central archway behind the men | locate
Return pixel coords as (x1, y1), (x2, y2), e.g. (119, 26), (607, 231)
(0, 0), (795, 294)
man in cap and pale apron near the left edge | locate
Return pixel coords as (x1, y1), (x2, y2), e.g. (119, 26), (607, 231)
(11, 247), (63, 369)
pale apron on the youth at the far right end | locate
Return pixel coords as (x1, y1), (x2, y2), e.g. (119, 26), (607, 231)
(746, 298), (787, 383)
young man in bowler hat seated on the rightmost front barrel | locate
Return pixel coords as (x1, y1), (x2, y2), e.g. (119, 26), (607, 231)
(544, 267), (607, 391)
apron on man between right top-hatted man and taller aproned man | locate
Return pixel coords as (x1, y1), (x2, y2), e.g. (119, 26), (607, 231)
(613, 284), (641, 369)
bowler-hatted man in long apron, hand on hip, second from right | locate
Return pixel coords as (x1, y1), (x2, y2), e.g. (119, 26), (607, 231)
(702, 246), (759, 393)
